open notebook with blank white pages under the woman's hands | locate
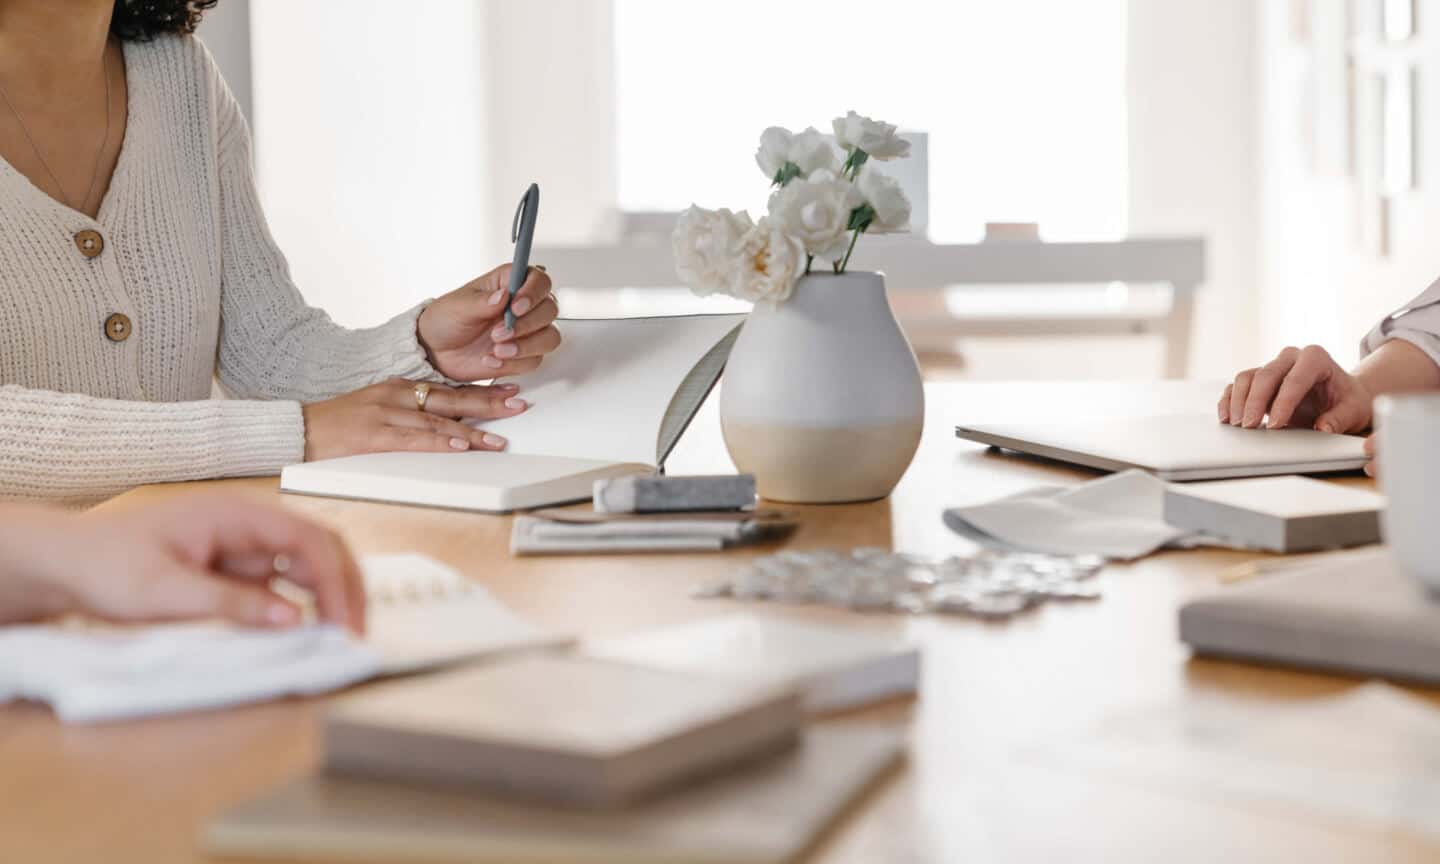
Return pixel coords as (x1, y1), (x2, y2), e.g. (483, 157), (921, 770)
(281, 315), (744, 511)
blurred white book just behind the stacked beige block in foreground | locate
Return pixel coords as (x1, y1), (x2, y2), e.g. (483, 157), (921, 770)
(582, 615), (920, 713)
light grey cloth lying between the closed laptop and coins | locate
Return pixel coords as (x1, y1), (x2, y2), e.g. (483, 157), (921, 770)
(945, 471), (1207, 560)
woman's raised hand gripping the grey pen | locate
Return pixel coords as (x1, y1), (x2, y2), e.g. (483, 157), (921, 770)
(416, 264), (560, 382)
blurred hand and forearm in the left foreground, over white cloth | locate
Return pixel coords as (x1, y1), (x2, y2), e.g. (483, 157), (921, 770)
(0, 495), (366, 634)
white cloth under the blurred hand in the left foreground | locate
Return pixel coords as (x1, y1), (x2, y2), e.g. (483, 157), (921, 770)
(0, 624), (382, 723)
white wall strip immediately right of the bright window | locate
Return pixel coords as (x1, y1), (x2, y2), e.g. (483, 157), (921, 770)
(1128, 0), (1255, 377)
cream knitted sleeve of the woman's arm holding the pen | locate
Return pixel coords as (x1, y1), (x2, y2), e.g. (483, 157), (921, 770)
(206, 58), (446, 402)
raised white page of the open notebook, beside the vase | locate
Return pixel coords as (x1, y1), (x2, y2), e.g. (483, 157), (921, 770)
(477, 315), (744, 465)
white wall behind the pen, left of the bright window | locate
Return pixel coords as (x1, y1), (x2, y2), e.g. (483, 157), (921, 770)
(243, 0), (615, 325)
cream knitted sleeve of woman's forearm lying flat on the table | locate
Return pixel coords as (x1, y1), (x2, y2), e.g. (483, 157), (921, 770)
(0, 384), (305, 505)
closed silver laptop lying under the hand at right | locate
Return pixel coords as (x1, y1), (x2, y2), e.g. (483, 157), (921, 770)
(955, 413), (1365, 480)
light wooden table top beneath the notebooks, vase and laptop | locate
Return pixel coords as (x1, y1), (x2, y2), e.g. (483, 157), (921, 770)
(0, 382), (1440, 864)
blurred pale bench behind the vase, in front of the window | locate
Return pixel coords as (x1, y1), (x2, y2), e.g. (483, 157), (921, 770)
(531, 234), (1205, 379)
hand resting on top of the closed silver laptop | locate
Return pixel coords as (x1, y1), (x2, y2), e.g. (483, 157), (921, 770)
(1217, 346), (1375, 432)
